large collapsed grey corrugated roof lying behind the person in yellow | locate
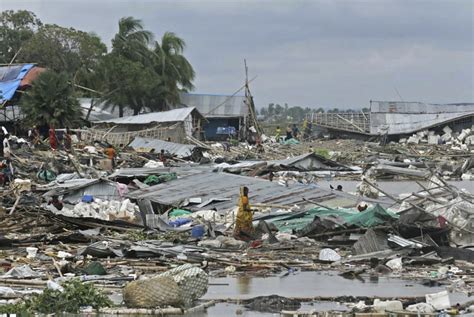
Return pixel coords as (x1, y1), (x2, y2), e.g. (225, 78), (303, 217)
(129, 172), (335, 210)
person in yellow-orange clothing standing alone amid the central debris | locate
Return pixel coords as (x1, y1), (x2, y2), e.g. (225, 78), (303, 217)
(234, 186), (255, 241)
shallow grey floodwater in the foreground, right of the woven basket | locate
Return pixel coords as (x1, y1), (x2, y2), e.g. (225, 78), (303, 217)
(181, 272), (469, 317)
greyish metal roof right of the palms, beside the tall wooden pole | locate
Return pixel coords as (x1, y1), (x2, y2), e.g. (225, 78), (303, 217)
(180, 93), (248, 118)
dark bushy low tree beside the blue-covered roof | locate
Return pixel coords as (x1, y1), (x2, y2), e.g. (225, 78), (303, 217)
(20, 71), (81, 127)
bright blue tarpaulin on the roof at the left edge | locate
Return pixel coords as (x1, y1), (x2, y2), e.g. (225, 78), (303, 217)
(0, 64), (34, 103)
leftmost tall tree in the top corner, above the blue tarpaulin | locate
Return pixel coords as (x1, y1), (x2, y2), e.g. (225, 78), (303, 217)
(0, 10), (41, 64)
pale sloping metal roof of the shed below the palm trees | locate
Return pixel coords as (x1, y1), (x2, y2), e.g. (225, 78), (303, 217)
(99, 107), (196, 124)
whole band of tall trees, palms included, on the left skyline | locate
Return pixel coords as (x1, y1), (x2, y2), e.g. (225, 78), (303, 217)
(0, 11), (195, 115)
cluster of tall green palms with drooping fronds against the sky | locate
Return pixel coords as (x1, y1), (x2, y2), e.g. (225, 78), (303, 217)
(99, 17), (195, 116)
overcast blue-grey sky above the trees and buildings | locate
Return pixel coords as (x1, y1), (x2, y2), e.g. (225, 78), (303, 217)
(0, 0), (474, 108)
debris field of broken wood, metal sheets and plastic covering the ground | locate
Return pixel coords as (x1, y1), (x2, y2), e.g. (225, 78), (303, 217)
(0, 127), (474, 315)
